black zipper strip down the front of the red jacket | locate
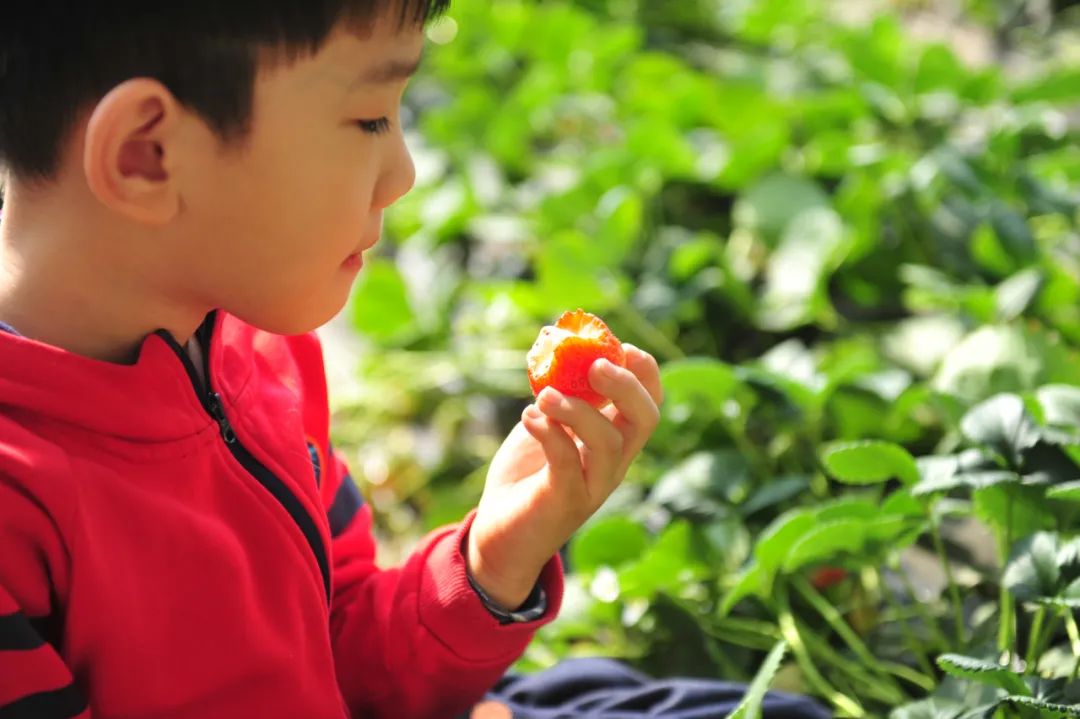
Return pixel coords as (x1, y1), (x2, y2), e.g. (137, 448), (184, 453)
(157, 311), (330, 603)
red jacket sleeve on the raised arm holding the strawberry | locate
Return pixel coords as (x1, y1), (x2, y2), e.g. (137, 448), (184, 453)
(291, 328), (563, 719)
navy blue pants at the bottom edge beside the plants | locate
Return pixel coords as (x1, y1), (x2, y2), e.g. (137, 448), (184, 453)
(462, 659), (832, 719)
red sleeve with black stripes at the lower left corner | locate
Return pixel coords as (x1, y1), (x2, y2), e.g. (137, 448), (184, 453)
(0, 474), (91, 719)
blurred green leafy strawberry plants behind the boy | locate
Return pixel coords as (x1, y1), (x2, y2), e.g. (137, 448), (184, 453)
(322, 0), (1080, 717)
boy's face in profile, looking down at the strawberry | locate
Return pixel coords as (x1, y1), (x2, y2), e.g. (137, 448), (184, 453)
(177, 14), (423, 334)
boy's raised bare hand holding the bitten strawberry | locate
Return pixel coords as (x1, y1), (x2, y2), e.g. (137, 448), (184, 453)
(467, 344), (663, 610)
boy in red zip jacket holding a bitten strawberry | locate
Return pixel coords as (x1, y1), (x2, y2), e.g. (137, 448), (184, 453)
(0, 0), (661, 719)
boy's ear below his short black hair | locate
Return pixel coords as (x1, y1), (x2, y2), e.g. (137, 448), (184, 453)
(82, 78), (181, 226)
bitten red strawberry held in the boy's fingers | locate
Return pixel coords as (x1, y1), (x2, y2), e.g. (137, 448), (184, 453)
(527, 310), (626, 407)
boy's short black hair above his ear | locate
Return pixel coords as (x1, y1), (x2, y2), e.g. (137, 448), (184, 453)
(0, 0), (449, 179)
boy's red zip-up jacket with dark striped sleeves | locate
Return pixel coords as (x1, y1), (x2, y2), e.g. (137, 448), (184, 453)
(0, 312), (562, 719)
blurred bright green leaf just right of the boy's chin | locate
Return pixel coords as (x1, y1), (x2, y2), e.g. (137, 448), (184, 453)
(351, 258), (416, 344)
